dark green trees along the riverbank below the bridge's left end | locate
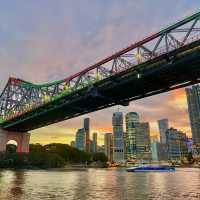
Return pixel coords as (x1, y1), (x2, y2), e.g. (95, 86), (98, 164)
(0, 143), (107, 169)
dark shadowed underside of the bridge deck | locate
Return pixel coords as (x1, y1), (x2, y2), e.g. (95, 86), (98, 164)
(3, 41), (200, 132)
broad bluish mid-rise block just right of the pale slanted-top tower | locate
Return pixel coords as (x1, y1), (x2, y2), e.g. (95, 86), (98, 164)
(166, 128), (188, 160)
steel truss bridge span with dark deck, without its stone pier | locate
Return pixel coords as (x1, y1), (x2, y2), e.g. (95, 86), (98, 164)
(0, 12), (200, 132)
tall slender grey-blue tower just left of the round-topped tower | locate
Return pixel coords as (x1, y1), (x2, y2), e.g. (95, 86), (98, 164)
(112, 112), (124, 162)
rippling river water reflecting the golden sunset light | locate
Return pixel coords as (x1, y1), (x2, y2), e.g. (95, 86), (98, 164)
(0, 168), (200, 200)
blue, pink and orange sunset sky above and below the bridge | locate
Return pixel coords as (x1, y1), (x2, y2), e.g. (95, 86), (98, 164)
(0, 0), (200, 144)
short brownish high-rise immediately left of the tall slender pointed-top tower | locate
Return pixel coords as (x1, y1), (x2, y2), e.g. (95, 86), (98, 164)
(104, 133), (113, 162)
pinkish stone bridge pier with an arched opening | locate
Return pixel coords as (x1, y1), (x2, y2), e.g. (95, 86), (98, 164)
(0, 128), (30, 153)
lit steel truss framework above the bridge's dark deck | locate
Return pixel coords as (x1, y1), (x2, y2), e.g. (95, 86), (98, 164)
(0, 12), (200, 130)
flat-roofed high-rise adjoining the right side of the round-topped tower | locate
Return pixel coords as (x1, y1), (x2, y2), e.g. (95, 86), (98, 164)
(136, 122), (151, 160)
